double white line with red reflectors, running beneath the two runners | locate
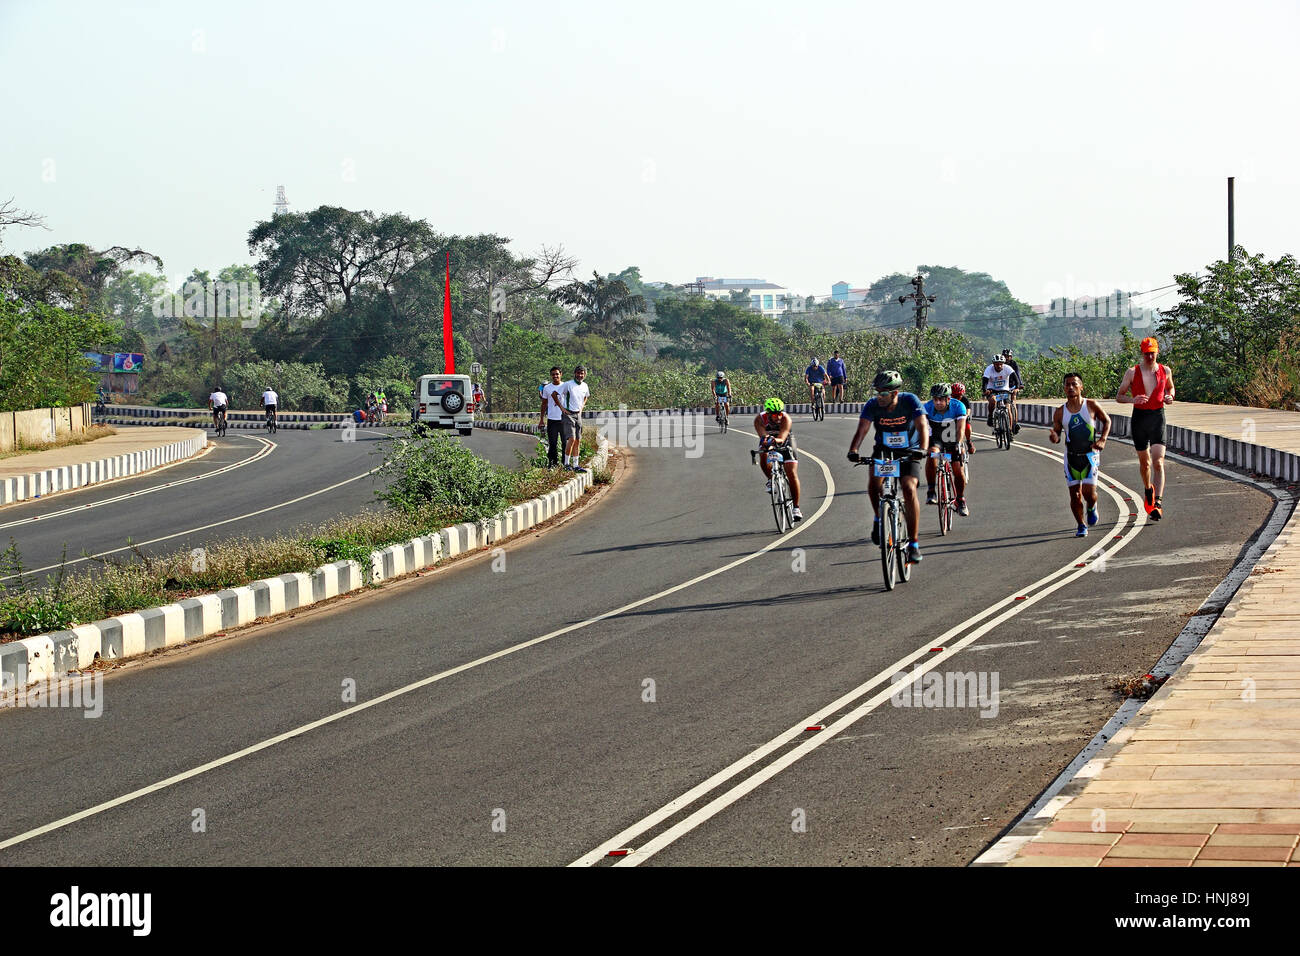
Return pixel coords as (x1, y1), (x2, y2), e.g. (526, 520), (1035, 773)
(569, 445), (1145, 866)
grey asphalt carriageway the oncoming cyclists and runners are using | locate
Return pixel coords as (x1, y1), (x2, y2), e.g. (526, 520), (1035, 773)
(0, 418), (1270, 865)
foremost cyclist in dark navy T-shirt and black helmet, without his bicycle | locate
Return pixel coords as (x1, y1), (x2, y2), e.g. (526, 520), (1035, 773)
(849, 369), (930, 563)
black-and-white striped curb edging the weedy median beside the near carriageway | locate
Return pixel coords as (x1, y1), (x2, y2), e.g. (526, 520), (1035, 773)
(0, 437), (610, 691)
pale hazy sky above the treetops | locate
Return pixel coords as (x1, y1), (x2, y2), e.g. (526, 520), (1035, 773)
(0, 0), (1300, 303)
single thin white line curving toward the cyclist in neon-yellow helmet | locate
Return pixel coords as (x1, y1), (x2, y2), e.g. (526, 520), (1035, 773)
(0, 450), (835, 851)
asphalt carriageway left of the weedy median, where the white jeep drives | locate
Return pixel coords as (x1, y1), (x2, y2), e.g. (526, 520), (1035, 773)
(0, 427), (529, 583)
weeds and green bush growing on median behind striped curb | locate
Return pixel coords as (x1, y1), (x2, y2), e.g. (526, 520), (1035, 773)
(0, 428), (597, 641)
